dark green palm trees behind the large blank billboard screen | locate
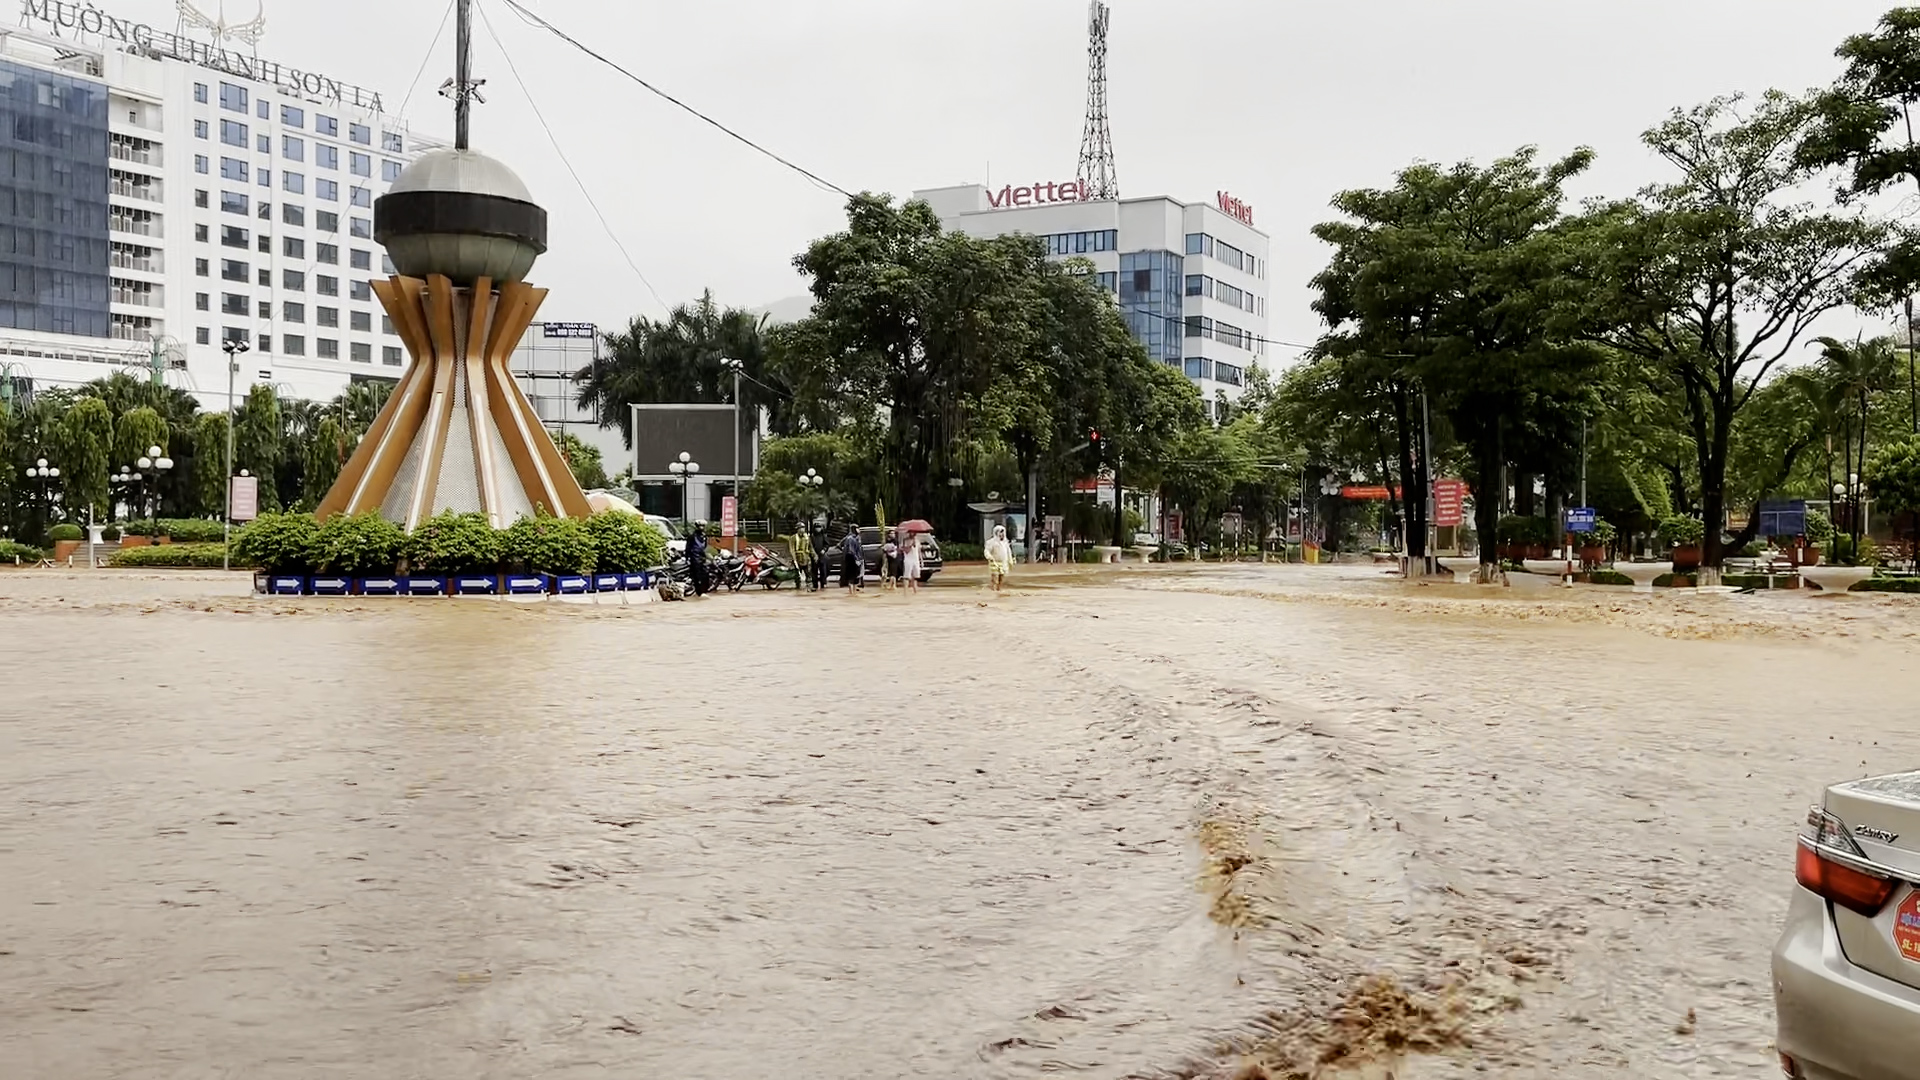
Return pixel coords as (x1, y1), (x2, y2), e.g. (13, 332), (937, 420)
(574, 292), (787, 446)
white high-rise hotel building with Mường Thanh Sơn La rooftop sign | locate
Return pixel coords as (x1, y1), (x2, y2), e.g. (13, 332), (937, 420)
(0, 0), (444, 404)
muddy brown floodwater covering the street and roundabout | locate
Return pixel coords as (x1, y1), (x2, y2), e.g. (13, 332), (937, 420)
(0, 565), (1920, 1080)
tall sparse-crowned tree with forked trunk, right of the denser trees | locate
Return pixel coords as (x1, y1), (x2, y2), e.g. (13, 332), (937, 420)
(1578, 92), (1891, 571)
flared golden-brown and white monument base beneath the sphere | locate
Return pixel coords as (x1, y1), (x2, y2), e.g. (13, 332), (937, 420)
(315, 267), (591, 532)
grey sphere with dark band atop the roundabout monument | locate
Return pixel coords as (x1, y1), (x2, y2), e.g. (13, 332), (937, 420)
(372, 150), (547, 284)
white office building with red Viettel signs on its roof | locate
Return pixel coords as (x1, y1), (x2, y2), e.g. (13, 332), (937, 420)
(914, 181), (1267, 407)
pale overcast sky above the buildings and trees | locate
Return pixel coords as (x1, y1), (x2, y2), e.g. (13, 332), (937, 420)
(120, 0), (1891, 363)
